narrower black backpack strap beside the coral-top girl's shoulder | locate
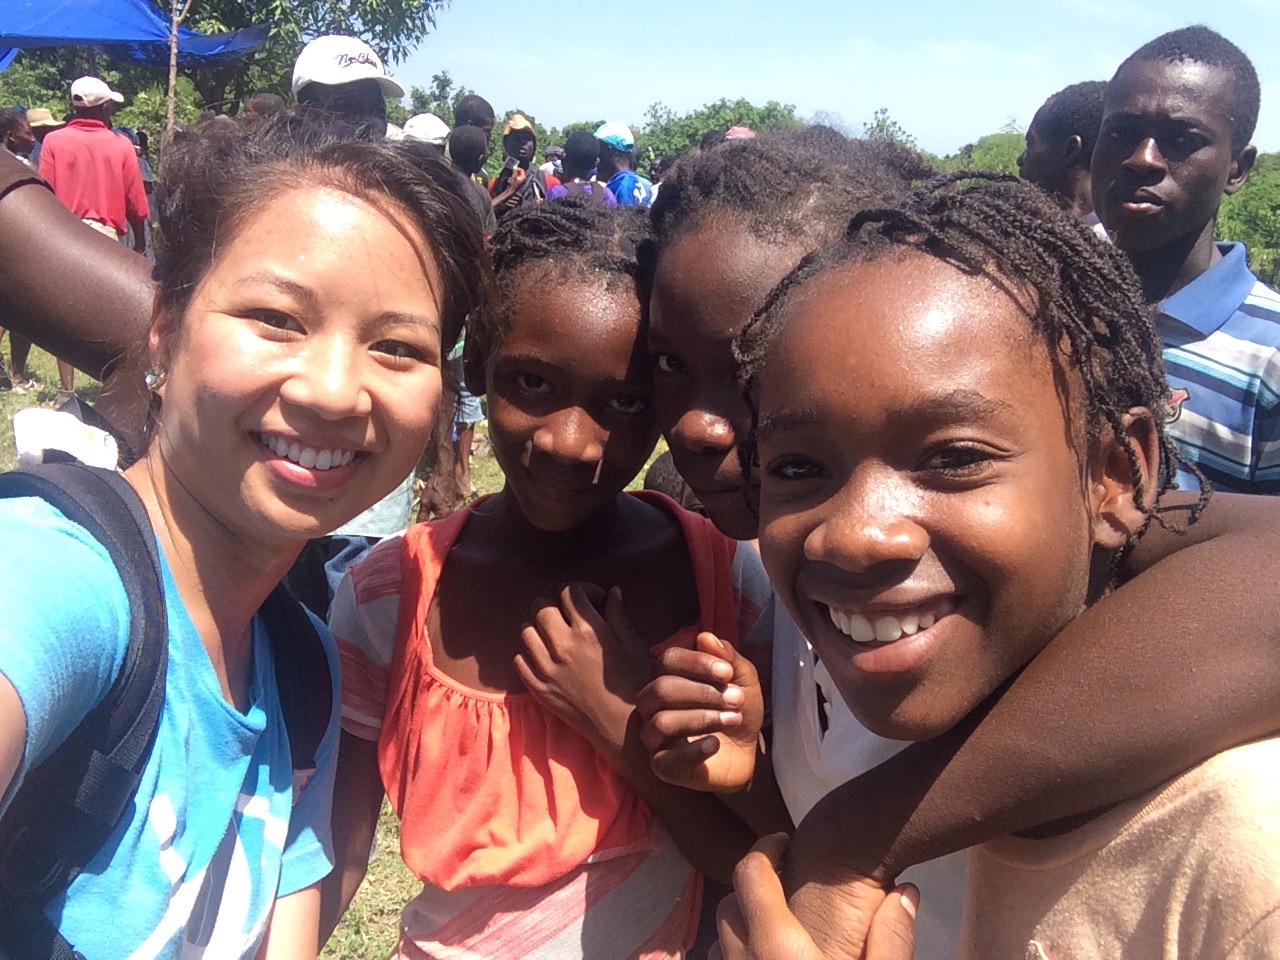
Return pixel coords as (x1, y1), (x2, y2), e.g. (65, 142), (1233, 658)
(259, 584), (333, 771)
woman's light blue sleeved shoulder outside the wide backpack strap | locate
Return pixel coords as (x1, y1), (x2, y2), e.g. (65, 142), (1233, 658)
(0, 498), (129, 813)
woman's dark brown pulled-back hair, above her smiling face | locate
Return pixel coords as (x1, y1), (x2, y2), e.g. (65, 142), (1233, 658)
(154, 114), (493, 352)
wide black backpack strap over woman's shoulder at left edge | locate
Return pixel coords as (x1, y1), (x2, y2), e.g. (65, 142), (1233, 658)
(0, 463), (169, 959)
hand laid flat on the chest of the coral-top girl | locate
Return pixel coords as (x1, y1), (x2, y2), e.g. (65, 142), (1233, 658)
(516, 584), (653, 755)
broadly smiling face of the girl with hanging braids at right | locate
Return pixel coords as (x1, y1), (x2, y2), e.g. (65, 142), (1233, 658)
(759, 253), (1140, 740)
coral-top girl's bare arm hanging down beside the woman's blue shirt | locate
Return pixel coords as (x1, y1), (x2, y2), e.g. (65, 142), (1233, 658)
(319, 731), (383, 946)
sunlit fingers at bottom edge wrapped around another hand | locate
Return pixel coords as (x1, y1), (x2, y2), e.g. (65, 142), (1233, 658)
(709, 833), (920, 960)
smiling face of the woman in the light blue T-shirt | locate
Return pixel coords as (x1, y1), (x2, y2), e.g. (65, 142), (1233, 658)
(148, 188), (440, 555)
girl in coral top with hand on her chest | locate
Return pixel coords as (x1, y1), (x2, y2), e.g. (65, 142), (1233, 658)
(325, 200), (785, 960)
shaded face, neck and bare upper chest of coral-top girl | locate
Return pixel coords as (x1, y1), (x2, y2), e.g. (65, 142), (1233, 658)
(429, 273), (698, 692)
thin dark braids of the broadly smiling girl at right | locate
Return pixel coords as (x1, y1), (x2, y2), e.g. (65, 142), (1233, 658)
(735, 172), (1211, 535)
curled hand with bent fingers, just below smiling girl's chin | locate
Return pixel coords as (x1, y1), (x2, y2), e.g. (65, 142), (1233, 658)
(636, 632), (764, 794)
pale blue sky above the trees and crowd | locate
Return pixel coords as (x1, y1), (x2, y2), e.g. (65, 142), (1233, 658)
(390, 0), (1280, 154)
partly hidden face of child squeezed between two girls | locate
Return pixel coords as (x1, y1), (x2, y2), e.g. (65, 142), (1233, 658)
(649, 215), (805, 540)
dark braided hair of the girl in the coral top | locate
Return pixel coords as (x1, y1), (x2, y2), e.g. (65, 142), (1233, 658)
(463, 197), (653, 397)
